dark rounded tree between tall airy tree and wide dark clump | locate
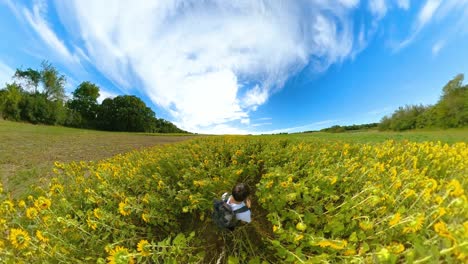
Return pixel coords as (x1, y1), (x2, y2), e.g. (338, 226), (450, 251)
(67, 82), (99, 127)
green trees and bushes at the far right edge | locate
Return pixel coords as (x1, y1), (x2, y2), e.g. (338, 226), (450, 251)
(379, 74), (468, 131)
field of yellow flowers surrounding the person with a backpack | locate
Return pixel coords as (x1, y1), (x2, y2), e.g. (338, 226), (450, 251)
(0, 136), (468, 263)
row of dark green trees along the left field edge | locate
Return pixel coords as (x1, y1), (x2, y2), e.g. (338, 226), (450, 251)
(0, 61), (187, 133)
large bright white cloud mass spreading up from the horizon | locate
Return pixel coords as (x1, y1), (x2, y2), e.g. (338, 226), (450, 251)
(48, 0), (359, 132)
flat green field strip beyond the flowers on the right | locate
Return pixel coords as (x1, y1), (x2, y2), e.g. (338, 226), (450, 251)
(275, 128), (468, 144)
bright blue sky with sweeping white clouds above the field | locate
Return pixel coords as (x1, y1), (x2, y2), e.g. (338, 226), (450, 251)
(0, 0), (468, 134)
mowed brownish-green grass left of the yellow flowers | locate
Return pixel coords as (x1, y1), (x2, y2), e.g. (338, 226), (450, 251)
(0, 120), (193, 197)
